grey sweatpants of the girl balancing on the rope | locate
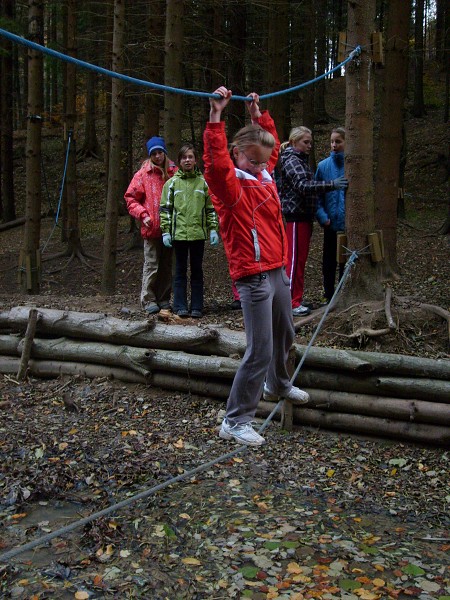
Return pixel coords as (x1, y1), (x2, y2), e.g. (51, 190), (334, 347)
(226, 267), (295, 426)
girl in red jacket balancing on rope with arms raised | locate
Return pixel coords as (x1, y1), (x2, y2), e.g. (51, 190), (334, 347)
(203, 86), (309, 446)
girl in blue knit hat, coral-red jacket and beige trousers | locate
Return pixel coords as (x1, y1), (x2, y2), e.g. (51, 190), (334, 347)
(125, 136), (178, 314)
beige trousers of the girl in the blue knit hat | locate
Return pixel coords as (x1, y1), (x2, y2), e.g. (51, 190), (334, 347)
(141, 238), (173, 308)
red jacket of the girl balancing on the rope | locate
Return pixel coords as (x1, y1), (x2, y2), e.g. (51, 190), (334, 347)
(203, 111), (287, 281)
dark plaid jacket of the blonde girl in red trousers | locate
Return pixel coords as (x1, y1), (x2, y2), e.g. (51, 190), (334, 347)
(280, 146), (334, 222)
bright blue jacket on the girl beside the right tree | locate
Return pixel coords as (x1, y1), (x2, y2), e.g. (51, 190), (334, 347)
(316, 152), (345, 231)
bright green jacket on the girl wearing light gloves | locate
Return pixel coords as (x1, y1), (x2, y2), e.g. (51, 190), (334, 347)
(160, 168), (218, 241)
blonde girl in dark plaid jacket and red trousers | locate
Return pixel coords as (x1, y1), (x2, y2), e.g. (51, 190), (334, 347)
(281, 127), (348, 316)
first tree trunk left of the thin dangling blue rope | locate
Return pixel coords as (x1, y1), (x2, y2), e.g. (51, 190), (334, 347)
(19, 0), (44, 294)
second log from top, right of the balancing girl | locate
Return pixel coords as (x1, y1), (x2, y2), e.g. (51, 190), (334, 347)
(295, 369), (450, 403)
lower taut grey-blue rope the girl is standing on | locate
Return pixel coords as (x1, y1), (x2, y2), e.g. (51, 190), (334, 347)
(0, 248), (365, 562)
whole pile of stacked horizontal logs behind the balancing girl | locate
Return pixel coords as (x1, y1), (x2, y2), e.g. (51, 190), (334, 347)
(0, 307), (450, 446)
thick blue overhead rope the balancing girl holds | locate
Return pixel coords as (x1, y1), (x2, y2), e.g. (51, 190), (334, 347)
(0, 29), (361, 102)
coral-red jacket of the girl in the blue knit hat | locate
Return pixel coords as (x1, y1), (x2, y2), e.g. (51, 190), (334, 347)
(124, 160), (178, 239)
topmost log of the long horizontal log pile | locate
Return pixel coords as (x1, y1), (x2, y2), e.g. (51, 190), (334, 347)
(0, 307), (450, 381)
